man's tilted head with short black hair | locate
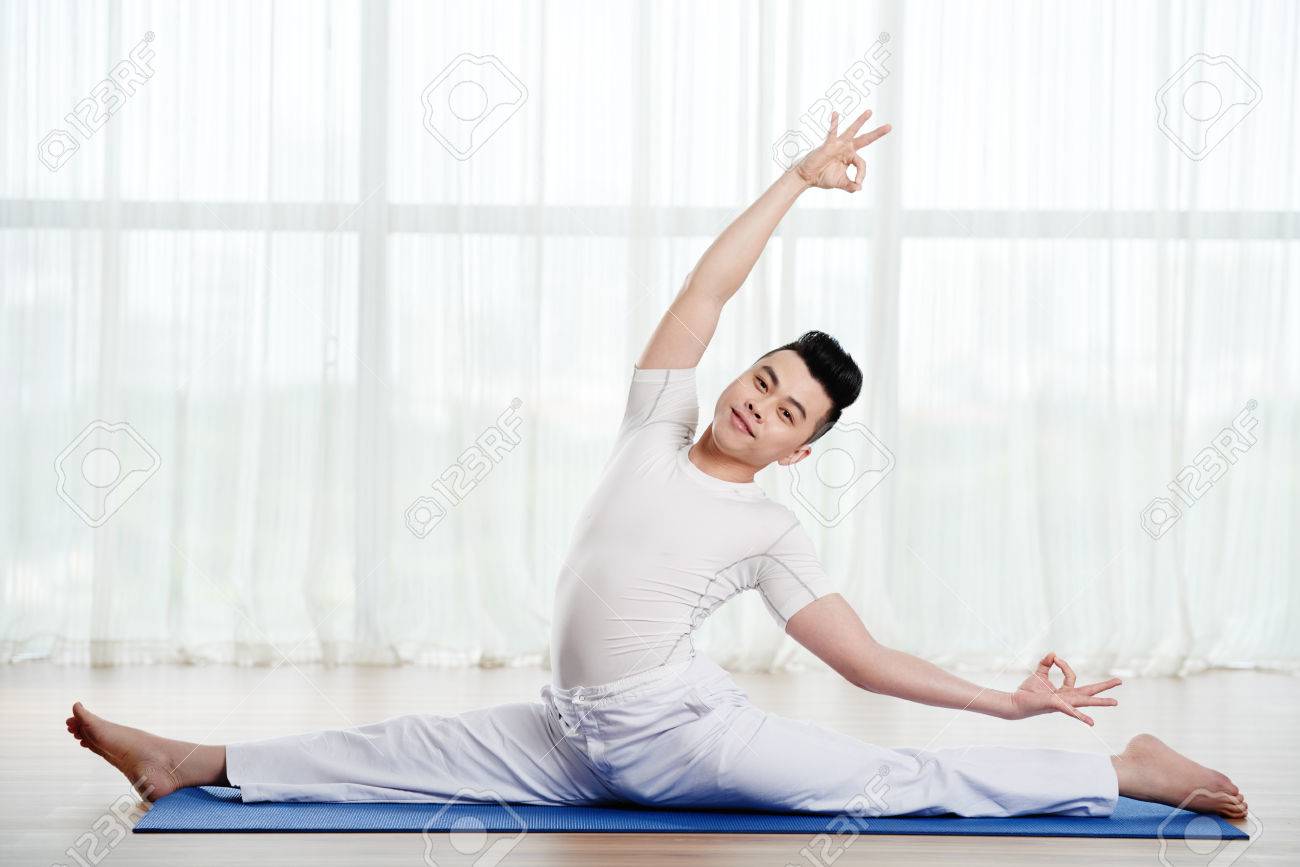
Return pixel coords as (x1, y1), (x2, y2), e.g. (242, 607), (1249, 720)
(714, 331), (862, 469)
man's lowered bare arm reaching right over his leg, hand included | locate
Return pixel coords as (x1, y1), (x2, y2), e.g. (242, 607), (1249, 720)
(785, 593), (1121, 725)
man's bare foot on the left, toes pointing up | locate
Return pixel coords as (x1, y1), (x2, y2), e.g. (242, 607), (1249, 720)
(66, 702), (225, 801)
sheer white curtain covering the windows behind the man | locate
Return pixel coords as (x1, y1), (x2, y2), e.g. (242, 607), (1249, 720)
(0, 0), (1300, 673)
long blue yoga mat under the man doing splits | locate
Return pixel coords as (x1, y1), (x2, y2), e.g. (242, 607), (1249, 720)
(135, 786), (1248, 840)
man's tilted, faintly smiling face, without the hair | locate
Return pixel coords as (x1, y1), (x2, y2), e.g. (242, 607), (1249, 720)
(714, 350), (831, 469)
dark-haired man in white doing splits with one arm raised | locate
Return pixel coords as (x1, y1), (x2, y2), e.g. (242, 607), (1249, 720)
(68, 112), (1247, 818)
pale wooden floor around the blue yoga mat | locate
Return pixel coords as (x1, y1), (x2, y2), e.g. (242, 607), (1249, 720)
(0, 663), (1300, 867)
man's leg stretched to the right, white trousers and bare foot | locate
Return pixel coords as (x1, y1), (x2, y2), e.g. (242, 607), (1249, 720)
(618, 684), (1247, 818)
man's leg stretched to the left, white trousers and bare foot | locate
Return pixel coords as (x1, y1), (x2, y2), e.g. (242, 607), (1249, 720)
(68, 702), (614, 803)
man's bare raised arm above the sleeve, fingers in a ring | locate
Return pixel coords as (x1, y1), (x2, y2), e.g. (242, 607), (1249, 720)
(637, 109), (889, 369)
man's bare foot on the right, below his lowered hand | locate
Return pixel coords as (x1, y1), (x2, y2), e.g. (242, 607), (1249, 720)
(1110, 734), (1247, 819)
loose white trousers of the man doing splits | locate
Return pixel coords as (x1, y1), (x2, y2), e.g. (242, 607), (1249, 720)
(226, 655), (1118, 816)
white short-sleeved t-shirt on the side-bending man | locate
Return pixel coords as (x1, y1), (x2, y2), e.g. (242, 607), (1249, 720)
(551, 368), (835, 689)
